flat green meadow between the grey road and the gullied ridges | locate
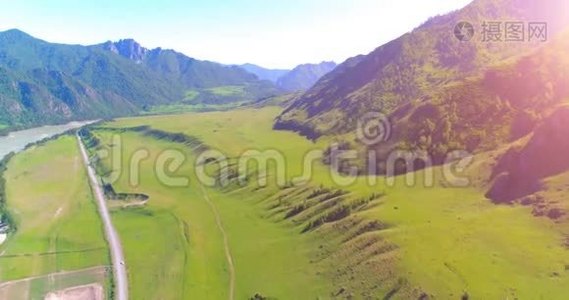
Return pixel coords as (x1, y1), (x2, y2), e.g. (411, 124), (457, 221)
(89, 131), (327, 299)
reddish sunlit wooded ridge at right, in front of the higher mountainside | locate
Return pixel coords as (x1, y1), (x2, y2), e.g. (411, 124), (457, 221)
(381, 32), (569, 163)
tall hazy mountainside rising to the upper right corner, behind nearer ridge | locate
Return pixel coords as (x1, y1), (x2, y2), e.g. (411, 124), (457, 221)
(275, 0), (568, 138)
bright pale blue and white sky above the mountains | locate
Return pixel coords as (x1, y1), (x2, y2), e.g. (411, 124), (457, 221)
(0, 0), (471, 68)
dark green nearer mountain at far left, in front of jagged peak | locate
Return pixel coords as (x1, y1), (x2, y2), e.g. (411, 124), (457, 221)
(0, 30), (181, 127)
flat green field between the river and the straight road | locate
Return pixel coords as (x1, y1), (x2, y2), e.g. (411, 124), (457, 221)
(0, 136), (109, 281)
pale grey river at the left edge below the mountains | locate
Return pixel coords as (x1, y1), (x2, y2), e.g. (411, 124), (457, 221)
(0, 121), (93, 160)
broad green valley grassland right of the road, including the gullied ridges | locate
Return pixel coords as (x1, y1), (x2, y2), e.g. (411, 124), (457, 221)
(98, 108), (569, 299)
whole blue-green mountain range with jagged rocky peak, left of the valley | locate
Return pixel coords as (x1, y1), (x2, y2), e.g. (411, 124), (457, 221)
(0, 29), (282, 131)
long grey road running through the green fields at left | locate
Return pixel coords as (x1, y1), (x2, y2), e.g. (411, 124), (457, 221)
(77, 135), (128, 300)
